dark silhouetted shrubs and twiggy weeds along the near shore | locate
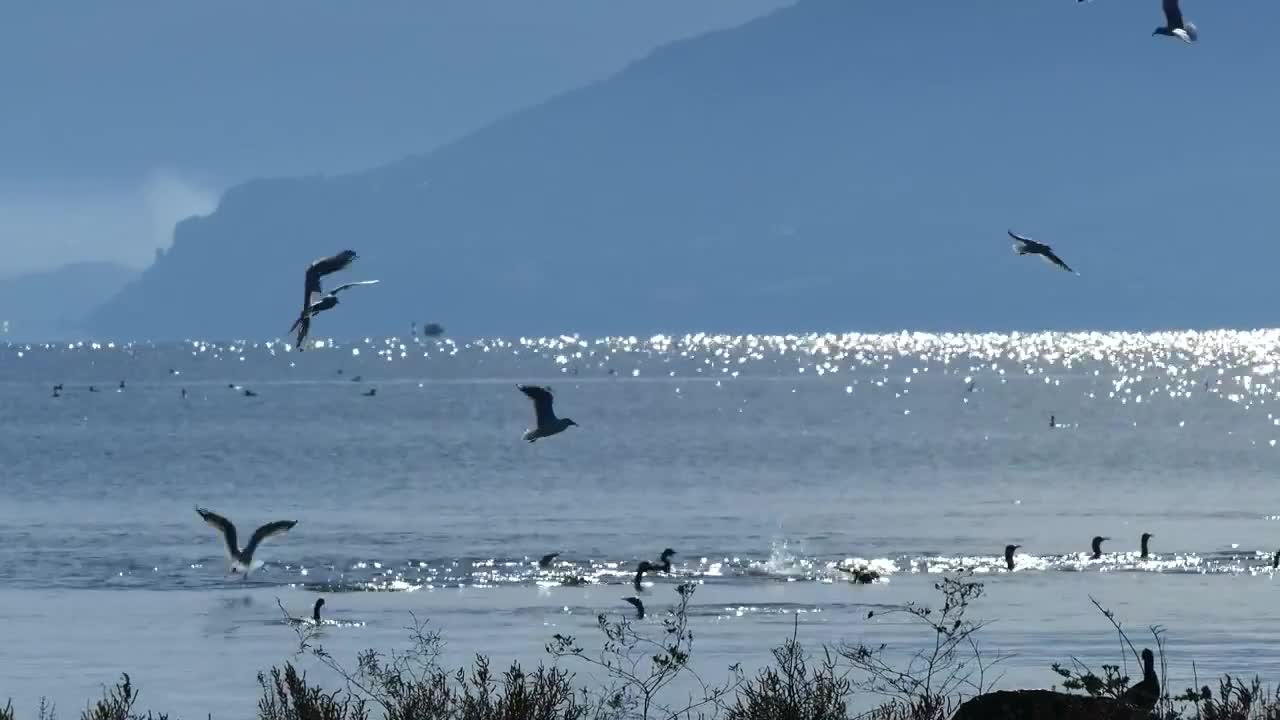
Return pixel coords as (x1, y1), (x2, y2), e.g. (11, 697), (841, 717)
(10, 575), (1280, 720)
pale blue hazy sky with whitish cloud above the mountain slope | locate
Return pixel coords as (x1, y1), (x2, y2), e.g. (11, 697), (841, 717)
(0, 0), (790, 275)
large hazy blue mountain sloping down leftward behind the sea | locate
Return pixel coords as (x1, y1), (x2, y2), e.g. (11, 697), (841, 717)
(92, 0), (1280, 340)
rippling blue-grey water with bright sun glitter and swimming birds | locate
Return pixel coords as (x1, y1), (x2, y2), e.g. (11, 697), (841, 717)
(0, 332), (1280, 717)
